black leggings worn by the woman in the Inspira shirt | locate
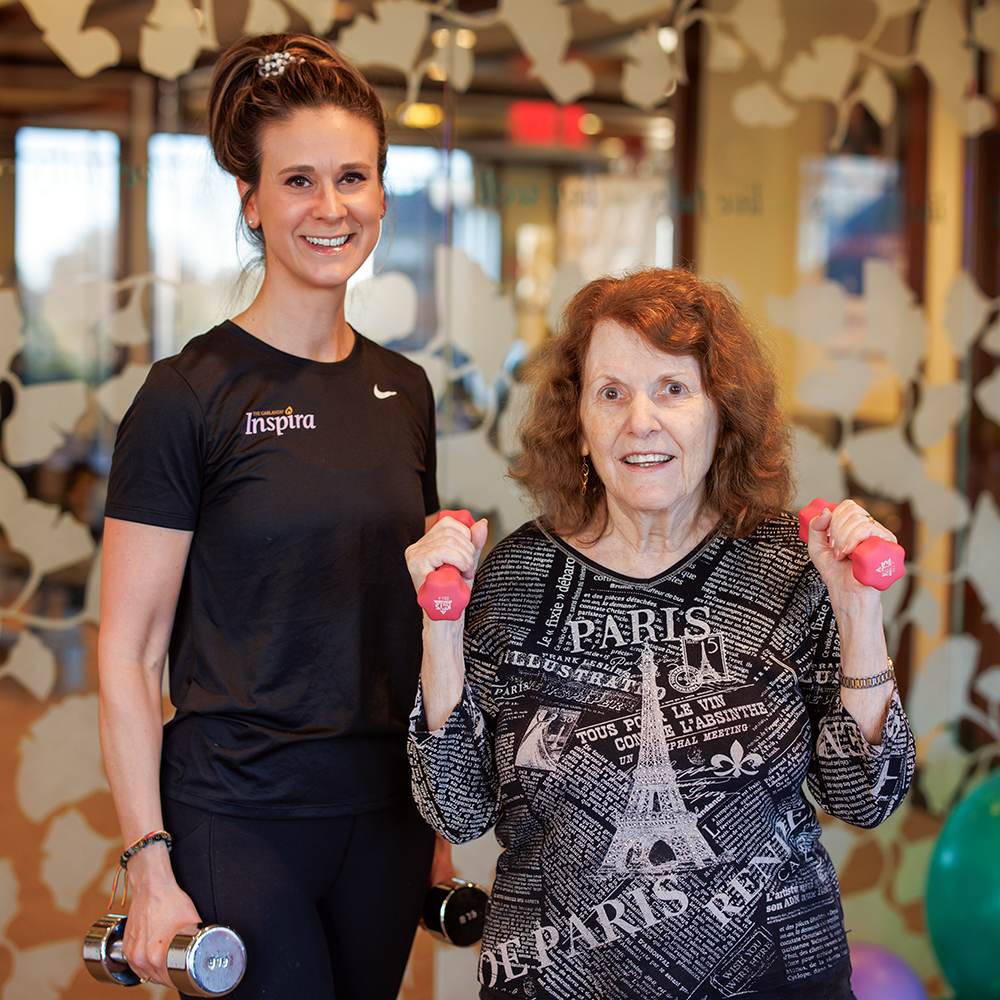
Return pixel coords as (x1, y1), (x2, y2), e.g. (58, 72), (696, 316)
(163, 798), (434, 1000)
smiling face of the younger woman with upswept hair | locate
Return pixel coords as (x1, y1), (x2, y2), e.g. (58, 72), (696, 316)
(237, 107), (385, 292)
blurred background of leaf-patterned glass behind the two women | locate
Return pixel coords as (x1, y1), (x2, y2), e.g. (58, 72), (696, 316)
(0, 0), (1000, 1000)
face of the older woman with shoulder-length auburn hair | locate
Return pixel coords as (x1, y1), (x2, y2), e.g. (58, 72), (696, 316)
(580, 320), (719, 522)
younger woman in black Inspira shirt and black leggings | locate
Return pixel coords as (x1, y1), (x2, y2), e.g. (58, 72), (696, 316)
(99, 35), (446, 1000)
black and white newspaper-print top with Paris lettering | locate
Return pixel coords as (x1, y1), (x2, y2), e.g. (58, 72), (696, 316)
(410, 517), (914, 1000)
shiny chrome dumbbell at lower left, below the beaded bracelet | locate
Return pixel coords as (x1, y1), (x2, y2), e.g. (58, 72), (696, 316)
(83, 913), (246, 997)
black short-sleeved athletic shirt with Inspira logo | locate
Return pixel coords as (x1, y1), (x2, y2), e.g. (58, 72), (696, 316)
(106, 322), (438, 818)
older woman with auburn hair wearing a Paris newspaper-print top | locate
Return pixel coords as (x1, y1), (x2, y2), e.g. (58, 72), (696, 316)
(407, 270), (913, 1000)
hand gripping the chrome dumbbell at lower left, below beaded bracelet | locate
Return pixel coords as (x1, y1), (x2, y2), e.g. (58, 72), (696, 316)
(122, 845), (201, 990)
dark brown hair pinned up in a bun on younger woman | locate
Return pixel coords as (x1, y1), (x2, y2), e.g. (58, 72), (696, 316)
(208, 35), (389, 258)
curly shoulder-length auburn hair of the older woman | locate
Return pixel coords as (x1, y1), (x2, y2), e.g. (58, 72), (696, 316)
(510, 268), (792, 540)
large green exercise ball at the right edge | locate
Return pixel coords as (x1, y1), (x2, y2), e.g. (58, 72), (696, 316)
(927, 770), (1000, 1000)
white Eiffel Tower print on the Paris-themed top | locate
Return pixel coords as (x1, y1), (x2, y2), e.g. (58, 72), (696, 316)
(601, 643), (717, 873)
